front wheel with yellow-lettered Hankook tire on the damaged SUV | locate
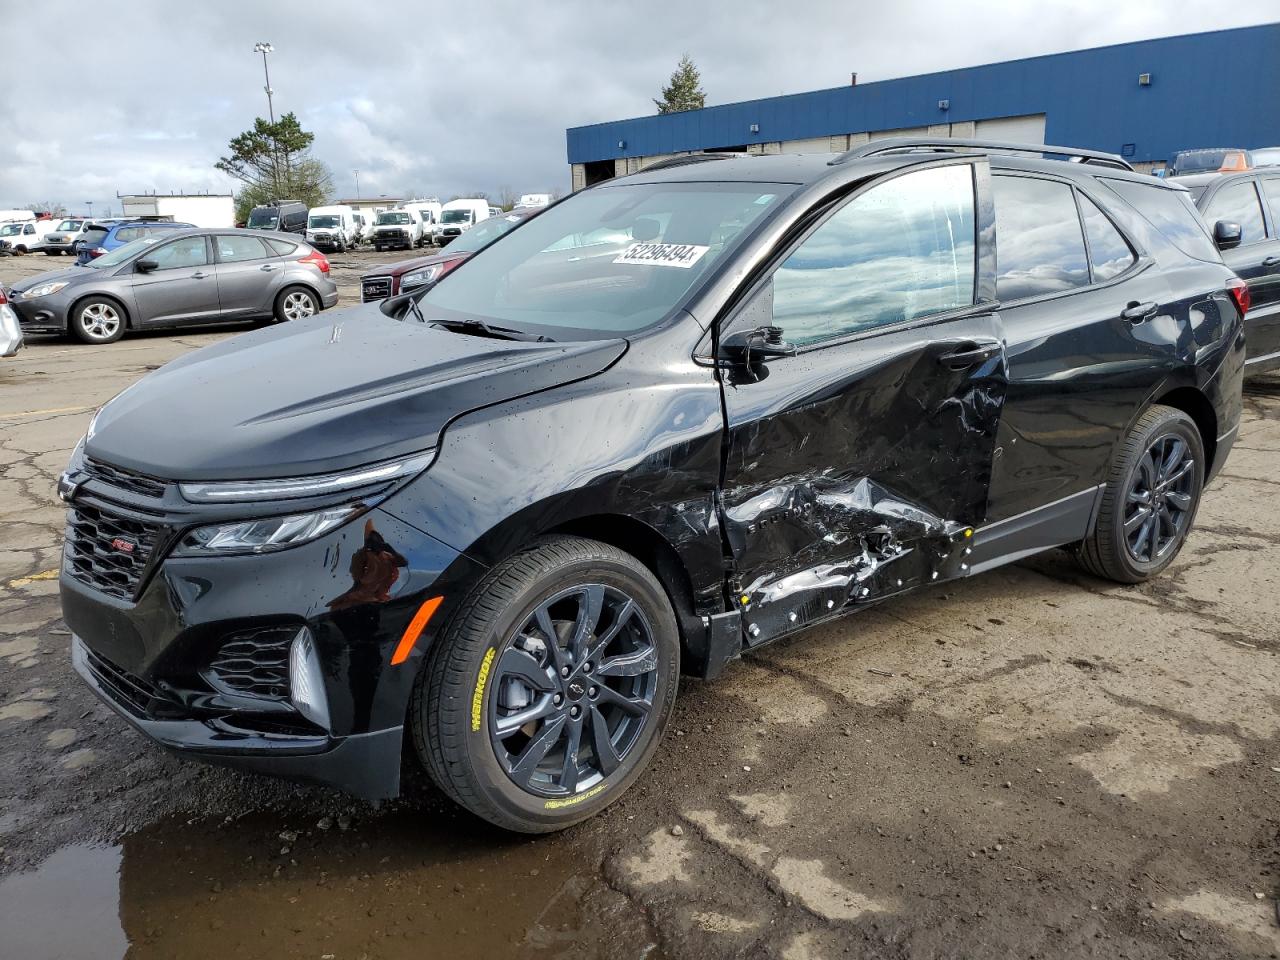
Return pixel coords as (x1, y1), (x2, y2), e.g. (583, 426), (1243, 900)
(410, 536), (680, 833)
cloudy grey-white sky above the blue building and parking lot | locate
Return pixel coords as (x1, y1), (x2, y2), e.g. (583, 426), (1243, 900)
(0, 0), (1280, 212)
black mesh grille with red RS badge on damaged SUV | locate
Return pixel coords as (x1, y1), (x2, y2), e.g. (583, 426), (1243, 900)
(63, 504), (160, 600)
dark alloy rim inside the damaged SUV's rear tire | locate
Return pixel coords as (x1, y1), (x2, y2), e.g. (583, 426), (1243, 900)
(1124, 434), (1196, 563)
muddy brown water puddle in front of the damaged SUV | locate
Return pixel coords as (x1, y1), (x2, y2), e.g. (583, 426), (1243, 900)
(0, 810), (660, 960)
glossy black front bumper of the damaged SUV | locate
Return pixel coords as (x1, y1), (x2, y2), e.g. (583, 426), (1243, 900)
(60, 471), (479, 799)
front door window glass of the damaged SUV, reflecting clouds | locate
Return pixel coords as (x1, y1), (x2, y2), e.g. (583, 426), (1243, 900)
(773, 164), (977, 344)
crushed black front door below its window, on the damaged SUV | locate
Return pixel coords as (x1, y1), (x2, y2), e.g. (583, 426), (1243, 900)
(722, 314), (1006, 644)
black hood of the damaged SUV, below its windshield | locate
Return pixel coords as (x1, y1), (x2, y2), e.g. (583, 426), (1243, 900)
(86, 307), (626, 480)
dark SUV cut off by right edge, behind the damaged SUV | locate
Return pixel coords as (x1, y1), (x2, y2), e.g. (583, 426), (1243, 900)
(1178, 166), (1280, 374)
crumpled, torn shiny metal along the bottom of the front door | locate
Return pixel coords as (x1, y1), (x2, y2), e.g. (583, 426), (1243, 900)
(726, 472), (973, 644)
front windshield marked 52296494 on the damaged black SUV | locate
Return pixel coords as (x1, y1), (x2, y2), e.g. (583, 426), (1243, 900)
(419, 183), (795, 339)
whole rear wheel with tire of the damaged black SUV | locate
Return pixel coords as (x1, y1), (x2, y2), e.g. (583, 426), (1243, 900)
(1076, 404), (1206, 584)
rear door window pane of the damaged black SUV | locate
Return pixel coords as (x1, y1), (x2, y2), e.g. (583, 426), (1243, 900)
(992, 177), (1089, 300)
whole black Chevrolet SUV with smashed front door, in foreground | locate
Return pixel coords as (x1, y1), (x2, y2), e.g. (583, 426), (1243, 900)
(59, 140), (1244, 832)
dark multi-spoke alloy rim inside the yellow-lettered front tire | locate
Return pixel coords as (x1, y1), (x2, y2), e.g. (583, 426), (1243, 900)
(488, 584), (658, 797)
